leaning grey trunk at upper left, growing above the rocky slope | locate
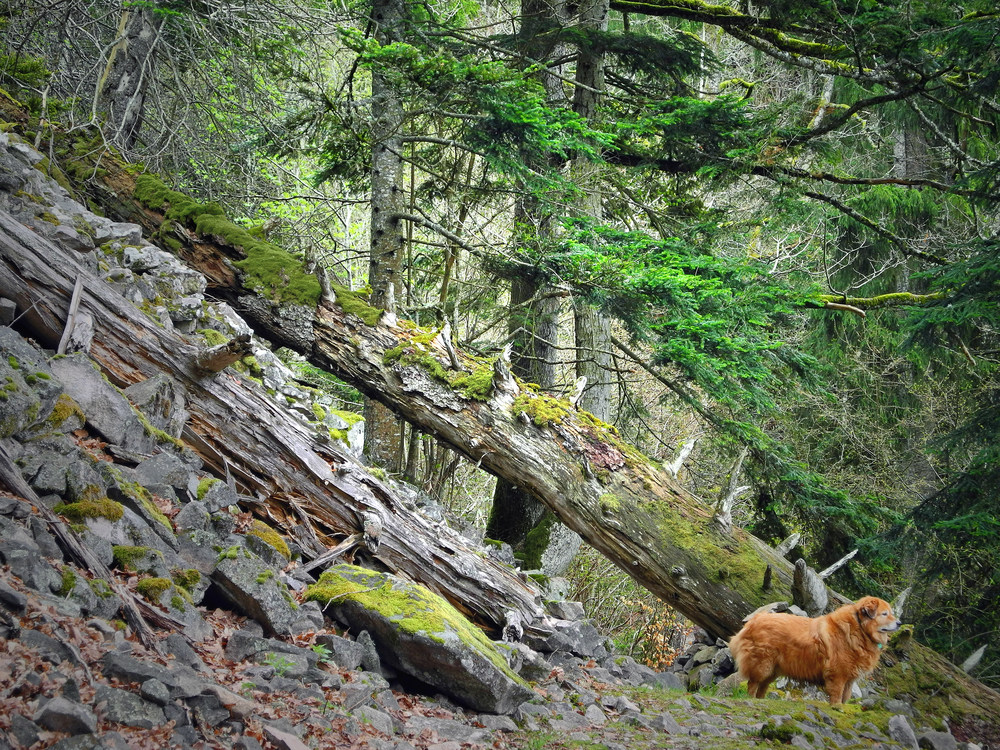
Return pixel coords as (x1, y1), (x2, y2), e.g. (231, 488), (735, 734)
(98, 3), (166, 151)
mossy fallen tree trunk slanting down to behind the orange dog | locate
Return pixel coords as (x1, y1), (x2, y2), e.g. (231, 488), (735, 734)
(76, 167), (792, 636)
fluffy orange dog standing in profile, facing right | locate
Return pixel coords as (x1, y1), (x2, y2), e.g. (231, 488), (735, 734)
(729, 596), (900, 705)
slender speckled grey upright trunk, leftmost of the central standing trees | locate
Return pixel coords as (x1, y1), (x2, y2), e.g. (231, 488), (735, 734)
(364, 0), (406, 472)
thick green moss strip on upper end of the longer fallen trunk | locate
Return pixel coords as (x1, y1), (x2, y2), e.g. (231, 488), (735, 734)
(135, 175), (320, 307)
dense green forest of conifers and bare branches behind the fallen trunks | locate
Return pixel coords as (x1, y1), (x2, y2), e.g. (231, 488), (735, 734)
(0, 0), (1000, 686)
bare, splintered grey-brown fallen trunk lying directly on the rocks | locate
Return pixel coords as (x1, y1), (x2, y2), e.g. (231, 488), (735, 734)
(0, 211), (541, 629)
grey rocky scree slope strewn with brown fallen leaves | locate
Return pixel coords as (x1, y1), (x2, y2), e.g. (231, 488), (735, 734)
(0, 134), (984, 750)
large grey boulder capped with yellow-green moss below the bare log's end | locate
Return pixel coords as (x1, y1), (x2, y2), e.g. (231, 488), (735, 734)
(306, 565), (534, 714)
